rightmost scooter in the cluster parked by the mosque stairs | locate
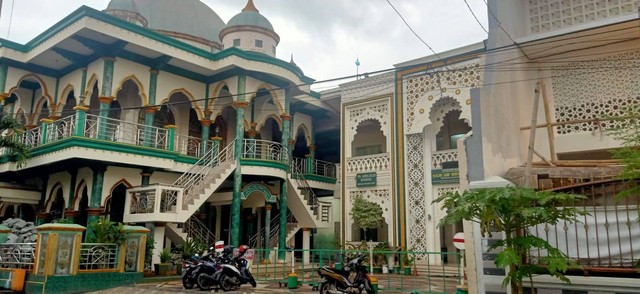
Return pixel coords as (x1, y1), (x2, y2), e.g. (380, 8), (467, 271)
(217, 245), (257, 292)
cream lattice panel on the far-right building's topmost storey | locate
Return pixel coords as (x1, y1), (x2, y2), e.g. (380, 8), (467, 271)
(529, 0), (640, 33)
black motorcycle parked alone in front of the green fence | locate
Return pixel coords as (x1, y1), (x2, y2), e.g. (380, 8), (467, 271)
(318, 255), (374, 294)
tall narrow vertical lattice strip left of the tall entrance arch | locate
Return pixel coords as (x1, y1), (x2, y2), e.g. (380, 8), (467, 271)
(407, 134), (427, 252)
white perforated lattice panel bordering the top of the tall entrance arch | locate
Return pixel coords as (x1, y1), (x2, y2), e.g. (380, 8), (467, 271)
(404, 63), (482, 129)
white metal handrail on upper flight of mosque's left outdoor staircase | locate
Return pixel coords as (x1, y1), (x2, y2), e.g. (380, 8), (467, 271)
(173, 140), (235, 204)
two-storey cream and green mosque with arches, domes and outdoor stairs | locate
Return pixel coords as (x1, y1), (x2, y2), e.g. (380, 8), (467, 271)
(0, 0), (339, 266)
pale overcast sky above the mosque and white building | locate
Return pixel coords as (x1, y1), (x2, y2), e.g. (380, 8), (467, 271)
(0, 0), (488, 90)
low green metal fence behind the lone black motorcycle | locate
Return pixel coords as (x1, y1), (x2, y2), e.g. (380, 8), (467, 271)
(251, 249), (462, 293)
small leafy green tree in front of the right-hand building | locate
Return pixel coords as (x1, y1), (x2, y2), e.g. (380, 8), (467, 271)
(434, 187), (586, 294)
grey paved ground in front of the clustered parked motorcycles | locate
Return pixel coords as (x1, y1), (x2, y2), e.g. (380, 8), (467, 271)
(93, 281), (318, 294)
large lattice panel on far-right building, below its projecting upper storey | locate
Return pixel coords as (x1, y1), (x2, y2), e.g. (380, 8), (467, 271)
(553, 51), (640, 135)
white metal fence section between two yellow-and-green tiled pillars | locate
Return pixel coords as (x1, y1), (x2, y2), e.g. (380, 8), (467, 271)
(79, 243), (118, 271)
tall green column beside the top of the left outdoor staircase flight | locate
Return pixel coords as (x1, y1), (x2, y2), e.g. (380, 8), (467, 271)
(230, 75), (248, 247)
